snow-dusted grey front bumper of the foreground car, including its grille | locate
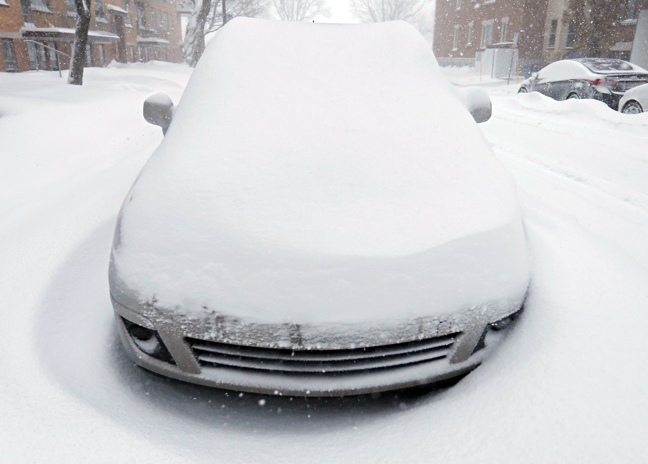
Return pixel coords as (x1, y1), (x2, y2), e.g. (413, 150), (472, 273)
(112, 298), (519, 397)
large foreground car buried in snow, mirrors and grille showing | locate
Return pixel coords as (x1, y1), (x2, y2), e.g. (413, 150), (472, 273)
(109, 19), (529, 396)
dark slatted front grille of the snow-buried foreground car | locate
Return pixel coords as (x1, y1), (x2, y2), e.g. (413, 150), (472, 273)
(186, 334), (459, 375)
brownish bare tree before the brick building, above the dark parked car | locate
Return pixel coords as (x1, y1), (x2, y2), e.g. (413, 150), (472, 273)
(563, 0), (628, 57)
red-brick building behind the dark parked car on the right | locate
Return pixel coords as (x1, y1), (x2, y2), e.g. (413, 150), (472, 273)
(434, 0), (648, 68)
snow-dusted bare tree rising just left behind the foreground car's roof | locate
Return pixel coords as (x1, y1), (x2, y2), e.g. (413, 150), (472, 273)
(183, 0), (268, 67)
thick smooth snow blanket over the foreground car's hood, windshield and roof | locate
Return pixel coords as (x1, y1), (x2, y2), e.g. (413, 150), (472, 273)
(114, 19), (527, 321)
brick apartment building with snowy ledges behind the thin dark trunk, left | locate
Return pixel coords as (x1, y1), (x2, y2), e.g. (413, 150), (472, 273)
(0, 0), (182, 71)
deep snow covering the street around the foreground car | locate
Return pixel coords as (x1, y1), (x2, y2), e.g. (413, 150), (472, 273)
(0, 63), (648, 464)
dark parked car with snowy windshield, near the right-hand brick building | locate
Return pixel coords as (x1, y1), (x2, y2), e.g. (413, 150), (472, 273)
(518, 58), (648, 110)
